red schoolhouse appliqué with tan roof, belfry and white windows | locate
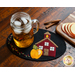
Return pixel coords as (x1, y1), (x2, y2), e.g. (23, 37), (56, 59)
(35, 32), (58, 57)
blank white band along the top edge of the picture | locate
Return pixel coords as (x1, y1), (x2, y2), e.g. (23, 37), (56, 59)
(0, 0), (75, 7)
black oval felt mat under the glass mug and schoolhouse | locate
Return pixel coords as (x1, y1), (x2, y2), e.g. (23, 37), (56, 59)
(6, 29), (66, 61)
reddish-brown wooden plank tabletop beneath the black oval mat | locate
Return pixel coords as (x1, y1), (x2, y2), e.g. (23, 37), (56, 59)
(0, 7), (75, 67)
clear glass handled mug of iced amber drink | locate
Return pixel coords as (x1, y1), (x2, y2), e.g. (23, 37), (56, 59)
(10, 12), (39, 48)
